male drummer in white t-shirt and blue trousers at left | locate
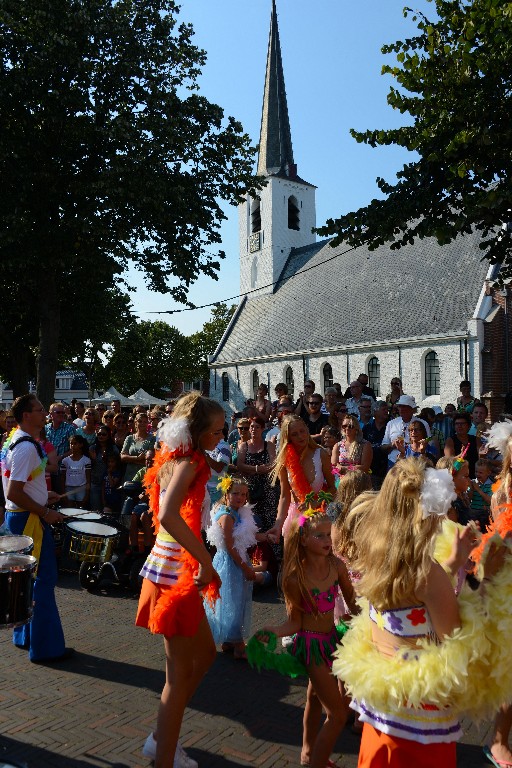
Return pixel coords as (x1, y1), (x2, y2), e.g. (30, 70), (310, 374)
(0, 395), (74, 664)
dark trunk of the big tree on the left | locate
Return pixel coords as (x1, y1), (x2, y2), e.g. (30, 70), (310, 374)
(36, 273), (60, 408)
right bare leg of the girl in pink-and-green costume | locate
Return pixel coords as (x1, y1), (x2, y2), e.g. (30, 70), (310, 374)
(308, 664), (347, 768)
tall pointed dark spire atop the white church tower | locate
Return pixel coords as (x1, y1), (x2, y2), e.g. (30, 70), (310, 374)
(257, 0), (297, 179)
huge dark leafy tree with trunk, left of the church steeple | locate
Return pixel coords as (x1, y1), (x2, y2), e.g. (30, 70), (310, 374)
(0, 0), (260, 402)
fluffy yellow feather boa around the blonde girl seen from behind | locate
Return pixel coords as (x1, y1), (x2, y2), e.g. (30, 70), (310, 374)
(333, 526), (512, 720)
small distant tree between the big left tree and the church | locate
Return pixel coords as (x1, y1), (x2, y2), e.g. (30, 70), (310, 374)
(103, 320), (190, 397)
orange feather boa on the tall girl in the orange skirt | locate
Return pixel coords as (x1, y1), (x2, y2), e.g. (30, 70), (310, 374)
(144, 446), (220, 634)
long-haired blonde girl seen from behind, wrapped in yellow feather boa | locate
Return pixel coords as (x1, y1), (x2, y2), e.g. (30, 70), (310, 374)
(333, 458), (512, 768)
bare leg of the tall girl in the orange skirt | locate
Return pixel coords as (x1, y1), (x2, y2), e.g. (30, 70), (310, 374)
(155, 616), (216, 768)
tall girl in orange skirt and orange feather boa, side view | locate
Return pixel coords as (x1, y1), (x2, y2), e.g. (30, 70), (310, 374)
(136, 392), (224, 768)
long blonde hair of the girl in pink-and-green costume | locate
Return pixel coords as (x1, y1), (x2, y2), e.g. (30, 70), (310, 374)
(282, 512), (336, 616)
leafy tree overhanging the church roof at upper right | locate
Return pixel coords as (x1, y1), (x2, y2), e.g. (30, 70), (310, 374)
(319, 0), (512, 277)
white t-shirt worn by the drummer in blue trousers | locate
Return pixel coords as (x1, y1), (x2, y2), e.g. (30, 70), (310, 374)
(2, 429), (48, 512)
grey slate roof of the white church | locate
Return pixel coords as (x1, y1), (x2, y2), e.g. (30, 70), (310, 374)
(211, 234), (489, 363)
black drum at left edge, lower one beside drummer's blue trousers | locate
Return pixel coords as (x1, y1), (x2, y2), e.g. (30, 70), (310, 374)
(0, 554), (37, 629)
